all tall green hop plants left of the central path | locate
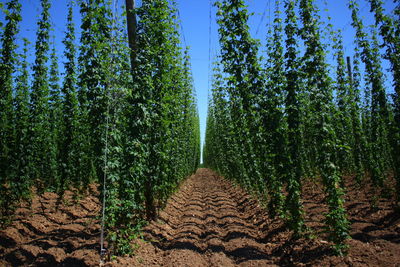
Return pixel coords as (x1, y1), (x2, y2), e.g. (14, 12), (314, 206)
(0, 0), (200, 254)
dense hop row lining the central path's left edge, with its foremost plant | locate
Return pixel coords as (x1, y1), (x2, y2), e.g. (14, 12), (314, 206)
(106, 0), (200, 254)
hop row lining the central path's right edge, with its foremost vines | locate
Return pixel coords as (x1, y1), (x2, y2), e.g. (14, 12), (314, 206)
(204, 0), (352, 252)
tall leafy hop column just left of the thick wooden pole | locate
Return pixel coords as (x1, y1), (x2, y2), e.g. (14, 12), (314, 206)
(79, 0), (112, 185)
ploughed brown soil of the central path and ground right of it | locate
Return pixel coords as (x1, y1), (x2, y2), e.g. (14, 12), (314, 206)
(109, 169), (400, 267)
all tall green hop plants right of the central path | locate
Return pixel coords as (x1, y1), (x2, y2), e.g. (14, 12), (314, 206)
(204, 0), (400, 253)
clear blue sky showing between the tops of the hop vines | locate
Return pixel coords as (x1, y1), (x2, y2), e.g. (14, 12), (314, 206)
(0, 0), (394, 160)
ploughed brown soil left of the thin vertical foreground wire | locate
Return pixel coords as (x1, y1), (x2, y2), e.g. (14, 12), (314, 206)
(0, 185), (100, 266)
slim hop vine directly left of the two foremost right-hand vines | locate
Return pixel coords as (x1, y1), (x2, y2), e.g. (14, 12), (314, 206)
(260, 1), (288, 217)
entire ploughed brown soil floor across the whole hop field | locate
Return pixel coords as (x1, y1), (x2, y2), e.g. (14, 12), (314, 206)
(0, 169), (400, 267)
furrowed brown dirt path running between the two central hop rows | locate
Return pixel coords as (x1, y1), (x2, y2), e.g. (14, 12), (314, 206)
(119, 169), (282, 267)
